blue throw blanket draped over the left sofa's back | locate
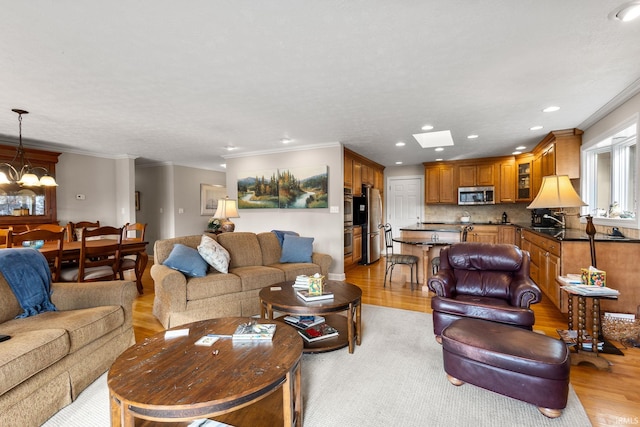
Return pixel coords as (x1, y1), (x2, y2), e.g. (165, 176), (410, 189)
(0, 248), (56, 318)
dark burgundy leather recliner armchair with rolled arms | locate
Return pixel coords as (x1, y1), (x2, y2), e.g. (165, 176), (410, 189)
(428, 242), (541, 341)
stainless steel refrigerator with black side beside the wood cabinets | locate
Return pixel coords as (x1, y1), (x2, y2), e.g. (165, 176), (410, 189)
(353, 185), (382, 265)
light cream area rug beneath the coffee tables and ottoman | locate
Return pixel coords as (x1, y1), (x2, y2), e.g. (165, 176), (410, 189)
(45, 305), (591, 427)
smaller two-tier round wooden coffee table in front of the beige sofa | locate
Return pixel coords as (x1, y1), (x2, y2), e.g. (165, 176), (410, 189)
(259, 280), (362, 353)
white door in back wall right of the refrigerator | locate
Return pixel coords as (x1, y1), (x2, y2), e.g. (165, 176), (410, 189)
(386, 176), (424, 249)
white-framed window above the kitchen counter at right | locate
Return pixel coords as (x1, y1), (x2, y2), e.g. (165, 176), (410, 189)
(582, 118), (640, 228)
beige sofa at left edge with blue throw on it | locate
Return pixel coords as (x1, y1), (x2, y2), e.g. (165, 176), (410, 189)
(0, 274), (138, 427)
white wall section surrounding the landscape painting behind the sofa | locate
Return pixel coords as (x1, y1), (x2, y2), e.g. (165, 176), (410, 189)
(226, 143), (344, 278)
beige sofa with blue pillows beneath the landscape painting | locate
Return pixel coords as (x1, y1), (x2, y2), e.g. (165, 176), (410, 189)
(151, 232), (331, 328)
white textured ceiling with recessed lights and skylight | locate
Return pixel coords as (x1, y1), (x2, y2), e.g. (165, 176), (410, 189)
(0, 0), (640, 170)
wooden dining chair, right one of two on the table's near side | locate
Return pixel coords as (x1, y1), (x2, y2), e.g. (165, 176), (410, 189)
(60, 226), (122, 282)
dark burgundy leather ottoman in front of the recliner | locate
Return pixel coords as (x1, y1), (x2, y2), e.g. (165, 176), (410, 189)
(442, 319), (571, 418)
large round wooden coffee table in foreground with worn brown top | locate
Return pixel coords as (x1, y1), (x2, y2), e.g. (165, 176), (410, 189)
(107, 317), (302, 427)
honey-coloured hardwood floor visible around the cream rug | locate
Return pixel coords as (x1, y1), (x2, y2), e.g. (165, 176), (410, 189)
(133, 259), (640, 427)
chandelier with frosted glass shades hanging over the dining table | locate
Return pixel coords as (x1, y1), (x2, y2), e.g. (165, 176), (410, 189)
(0, 108), (58, 187)
